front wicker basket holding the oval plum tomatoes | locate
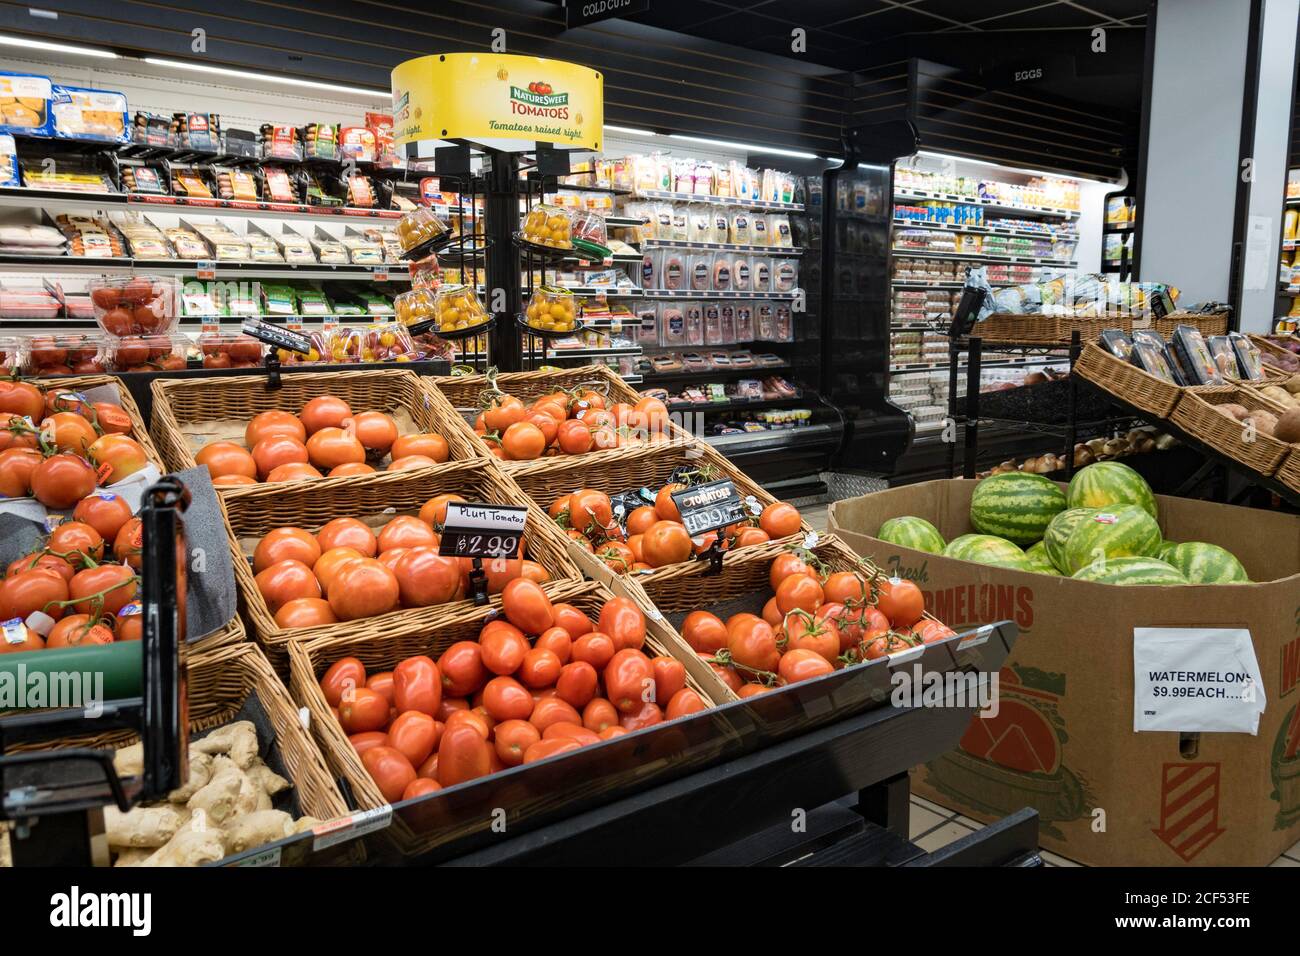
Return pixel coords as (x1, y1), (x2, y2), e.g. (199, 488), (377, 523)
(289, 574), (731, 822)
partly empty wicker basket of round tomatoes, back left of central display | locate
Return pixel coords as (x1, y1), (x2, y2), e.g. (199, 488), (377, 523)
(151, 368), (482, 494)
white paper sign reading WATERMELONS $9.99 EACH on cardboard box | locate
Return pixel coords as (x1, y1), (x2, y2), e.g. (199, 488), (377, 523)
(1134, 627), (1266, 735)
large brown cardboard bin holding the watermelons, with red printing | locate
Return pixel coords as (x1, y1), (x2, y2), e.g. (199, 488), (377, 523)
(828, 479), (1300, 866)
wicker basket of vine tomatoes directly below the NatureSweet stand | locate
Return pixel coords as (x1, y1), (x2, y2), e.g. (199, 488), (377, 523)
(428, 365), (694, 475)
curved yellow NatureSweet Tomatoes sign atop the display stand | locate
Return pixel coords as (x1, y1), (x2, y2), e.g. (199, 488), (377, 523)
(393, 53), (605, 150)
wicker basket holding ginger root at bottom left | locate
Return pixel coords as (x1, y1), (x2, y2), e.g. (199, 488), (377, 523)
(5, 644), (347, 821)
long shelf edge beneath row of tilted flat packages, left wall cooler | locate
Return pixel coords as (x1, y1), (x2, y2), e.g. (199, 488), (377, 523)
(0, 255), (411, 282)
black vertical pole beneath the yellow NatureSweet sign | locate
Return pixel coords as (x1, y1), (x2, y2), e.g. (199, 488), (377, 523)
(484, 151), (524, 372)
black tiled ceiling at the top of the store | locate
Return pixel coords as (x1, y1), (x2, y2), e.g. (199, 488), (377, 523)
(608, 0), (1151, 70)
